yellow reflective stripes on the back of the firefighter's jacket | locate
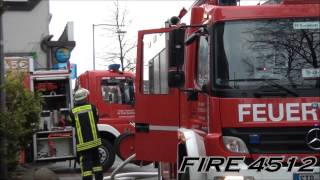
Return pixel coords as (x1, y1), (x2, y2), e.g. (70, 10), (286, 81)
(72, 105), (101, 151)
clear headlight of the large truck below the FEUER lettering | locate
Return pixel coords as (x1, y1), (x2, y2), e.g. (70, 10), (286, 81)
(223, 136), (249, 153)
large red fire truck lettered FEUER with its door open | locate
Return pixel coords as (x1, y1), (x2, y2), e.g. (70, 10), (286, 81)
(135, 0), (320, 180)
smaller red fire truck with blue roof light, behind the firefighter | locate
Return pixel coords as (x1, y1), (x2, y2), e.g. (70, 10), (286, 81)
(75, 65), (135, 170)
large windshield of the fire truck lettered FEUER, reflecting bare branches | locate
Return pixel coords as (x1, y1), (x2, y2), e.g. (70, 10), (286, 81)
(214, 18), (320, 91)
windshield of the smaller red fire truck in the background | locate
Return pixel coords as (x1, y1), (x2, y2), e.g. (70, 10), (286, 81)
(101, 77), (134, 104)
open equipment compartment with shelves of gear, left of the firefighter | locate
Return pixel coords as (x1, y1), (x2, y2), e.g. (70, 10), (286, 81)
(30, 70), (76, 161)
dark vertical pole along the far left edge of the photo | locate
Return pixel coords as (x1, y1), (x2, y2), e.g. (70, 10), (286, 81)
(0, 0), (8, 180)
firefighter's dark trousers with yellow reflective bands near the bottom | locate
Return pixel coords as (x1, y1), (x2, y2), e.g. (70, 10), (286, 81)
(79, 148), (103, 180)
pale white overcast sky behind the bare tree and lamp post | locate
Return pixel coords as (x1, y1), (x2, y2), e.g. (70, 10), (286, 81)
(50, 0), (257, 75)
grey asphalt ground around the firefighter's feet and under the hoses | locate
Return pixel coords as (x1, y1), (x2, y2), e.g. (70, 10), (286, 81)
(47, 159), (157, 180)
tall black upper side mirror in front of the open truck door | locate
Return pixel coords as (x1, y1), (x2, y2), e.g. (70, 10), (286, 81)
(168, 29), (185, 67)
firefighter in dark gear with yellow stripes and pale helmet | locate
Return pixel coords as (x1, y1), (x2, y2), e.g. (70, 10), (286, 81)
(70, 88), (103, 180)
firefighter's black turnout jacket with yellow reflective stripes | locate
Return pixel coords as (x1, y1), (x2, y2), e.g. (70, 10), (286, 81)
(70, 104), (101, 152)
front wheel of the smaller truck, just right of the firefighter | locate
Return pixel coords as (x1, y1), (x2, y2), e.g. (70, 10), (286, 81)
(98, 139), (116, 172)
